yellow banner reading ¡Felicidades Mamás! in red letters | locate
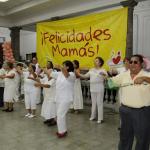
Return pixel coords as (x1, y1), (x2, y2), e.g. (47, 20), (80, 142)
(37, 8), (128, 69)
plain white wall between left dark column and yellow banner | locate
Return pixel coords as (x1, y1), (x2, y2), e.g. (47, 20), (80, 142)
(20, 30), (36, 59)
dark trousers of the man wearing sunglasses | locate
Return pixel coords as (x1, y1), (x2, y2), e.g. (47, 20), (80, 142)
(118, 106), (150, 150)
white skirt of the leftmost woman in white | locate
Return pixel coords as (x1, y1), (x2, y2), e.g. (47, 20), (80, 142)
(4, 85), (16, 103)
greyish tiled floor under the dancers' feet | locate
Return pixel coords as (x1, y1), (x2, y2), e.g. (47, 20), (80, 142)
(0, 103), (119, 150)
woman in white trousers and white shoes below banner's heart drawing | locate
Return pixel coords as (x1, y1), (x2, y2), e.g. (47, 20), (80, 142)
(76, 57), (107, 123)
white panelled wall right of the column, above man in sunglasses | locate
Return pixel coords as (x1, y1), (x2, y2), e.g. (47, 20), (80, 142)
(133, 1), (150, 57)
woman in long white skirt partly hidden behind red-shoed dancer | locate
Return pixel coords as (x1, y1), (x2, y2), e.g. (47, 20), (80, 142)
(73, 60), (83, 113)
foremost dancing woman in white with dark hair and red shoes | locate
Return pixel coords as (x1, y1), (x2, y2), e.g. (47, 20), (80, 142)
(50, 61), (76, 138)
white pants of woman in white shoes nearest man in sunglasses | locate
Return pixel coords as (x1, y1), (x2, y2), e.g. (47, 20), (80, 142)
(91, 91), (104, 121)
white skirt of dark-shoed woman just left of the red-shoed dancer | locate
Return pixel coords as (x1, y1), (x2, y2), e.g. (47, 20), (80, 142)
(41, 99), (56, 120)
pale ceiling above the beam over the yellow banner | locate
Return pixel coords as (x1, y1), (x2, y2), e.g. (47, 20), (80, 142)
(0, 0), (148, 28)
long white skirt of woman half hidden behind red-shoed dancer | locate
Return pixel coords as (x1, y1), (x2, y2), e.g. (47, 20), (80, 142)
(73, 79), (83, 110)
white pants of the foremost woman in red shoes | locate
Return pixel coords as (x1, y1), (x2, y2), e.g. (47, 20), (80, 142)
(56, 102), (71, 133)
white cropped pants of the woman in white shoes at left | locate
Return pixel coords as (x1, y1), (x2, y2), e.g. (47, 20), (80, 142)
(25, 91), (37, 109)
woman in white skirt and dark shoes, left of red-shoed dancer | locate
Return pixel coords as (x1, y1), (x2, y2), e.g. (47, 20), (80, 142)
(35, 69), (56, 126)
